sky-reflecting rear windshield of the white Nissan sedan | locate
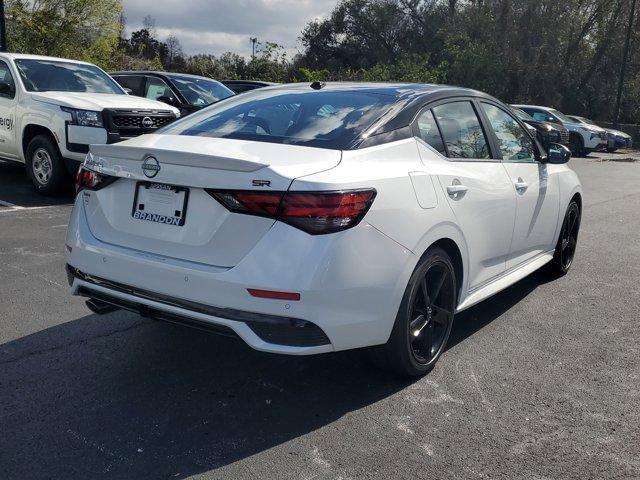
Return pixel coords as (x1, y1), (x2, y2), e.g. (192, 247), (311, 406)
(158, 88), (395, 150)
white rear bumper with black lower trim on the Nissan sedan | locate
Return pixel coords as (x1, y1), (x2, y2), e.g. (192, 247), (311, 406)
(67, 195), (417, 355)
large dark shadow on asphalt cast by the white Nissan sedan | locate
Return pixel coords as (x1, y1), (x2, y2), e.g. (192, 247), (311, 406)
(0, 274), (544, 479)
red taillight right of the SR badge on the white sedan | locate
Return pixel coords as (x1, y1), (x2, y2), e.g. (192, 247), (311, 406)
(207, 189), (376, 235)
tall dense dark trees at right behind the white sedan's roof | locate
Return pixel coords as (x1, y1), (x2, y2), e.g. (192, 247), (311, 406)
(294, 0), (640, 121)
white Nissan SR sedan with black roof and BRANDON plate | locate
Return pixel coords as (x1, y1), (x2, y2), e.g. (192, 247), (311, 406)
(66, 82), (582, 375)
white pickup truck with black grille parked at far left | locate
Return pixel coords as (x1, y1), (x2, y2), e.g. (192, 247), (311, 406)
(0, 53), (180, 195)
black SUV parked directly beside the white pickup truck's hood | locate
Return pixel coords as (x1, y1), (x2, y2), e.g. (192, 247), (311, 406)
(110, 71), (234, 116)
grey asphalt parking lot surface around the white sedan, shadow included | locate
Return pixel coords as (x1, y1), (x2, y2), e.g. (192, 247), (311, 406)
(0, 153), (640, 480)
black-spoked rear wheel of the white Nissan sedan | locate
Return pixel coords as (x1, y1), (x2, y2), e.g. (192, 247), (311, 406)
(371, 247), (458, 377)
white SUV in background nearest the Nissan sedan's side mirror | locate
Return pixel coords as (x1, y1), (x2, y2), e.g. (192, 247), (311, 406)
(514, 105), (608, 156)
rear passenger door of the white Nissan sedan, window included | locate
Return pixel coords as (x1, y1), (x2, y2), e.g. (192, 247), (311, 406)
(415, 100), (515, 291)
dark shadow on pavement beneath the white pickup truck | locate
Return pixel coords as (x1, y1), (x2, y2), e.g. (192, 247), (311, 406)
(0, 160), (73, 207)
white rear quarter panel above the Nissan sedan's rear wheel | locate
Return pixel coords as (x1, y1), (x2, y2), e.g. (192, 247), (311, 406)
(291, 138), (468, 318)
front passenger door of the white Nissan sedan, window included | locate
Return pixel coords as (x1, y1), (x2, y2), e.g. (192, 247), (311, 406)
(482, 102), (560, 270)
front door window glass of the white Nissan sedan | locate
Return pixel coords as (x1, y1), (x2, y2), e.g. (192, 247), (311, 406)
(482, 103), (536, 162)
